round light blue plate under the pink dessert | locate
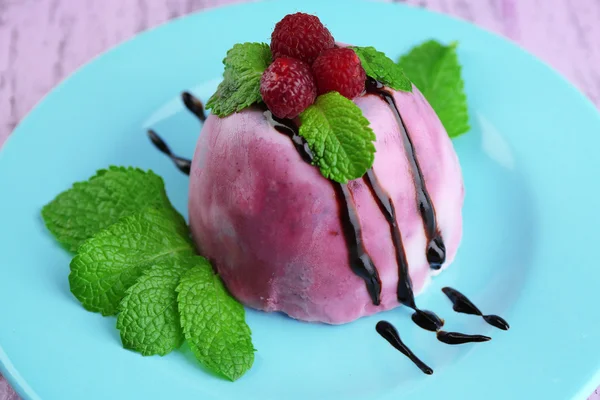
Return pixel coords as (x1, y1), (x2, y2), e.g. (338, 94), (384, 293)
(0, 0), (600, 400)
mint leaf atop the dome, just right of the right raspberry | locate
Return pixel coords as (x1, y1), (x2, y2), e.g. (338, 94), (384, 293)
(352, 46), (412, 92)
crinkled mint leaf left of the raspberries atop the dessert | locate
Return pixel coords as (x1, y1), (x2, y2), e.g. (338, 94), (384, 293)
(206, 43), (272, 117)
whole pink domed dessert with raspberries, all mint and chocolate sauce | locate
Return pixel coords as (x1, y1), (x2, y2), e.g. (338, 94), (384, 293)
(42, 13), (509, 381)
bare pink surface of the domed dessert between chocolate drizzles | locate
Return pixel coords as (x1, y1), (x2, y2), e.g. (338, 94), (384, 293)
(189, 88), (464, 324)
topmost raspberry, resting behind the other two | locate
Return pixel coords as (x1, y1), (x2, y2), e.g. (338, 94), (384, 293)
(271, 13), (335, 65)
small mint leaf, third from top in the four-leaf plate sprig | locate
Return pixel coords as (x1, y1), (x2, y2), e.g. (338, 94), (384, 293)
(117, 257), (194, 356)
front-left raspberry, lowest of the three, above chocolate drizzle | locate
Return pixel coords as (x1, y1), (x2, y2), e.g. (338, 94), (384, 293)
(260, 57), (317, 118)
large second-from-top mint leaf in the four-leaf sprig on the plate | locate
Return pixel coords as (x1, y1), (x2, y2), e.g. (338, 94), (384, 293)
(69, 209), (194, 315)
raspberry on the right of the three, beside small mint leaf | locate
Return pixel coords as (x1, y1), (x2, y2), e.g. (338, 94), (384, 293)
(312, 48), (367, 100)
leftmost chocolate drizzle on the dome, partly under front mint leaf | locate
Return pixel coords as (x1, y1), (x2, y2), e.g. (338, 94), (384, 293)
(265, 110), (381, 306)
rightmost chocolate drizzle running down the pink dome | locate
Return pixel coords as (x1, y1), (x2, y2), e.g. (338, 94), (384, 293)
(366, 77), (446, 269)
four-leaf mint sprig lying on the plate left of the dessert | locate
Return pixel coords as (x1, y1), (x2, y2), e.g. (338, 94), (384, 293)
(43, 167), (255, 380)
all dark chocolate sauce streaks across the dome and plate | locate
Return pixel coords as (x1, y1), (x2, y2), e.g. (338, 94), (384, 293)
(148, 82), (500, 375)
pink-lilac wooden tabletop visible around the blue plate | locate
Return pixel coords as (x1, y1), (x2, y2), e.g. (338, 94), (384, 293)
(0, 0), (600, 400)
